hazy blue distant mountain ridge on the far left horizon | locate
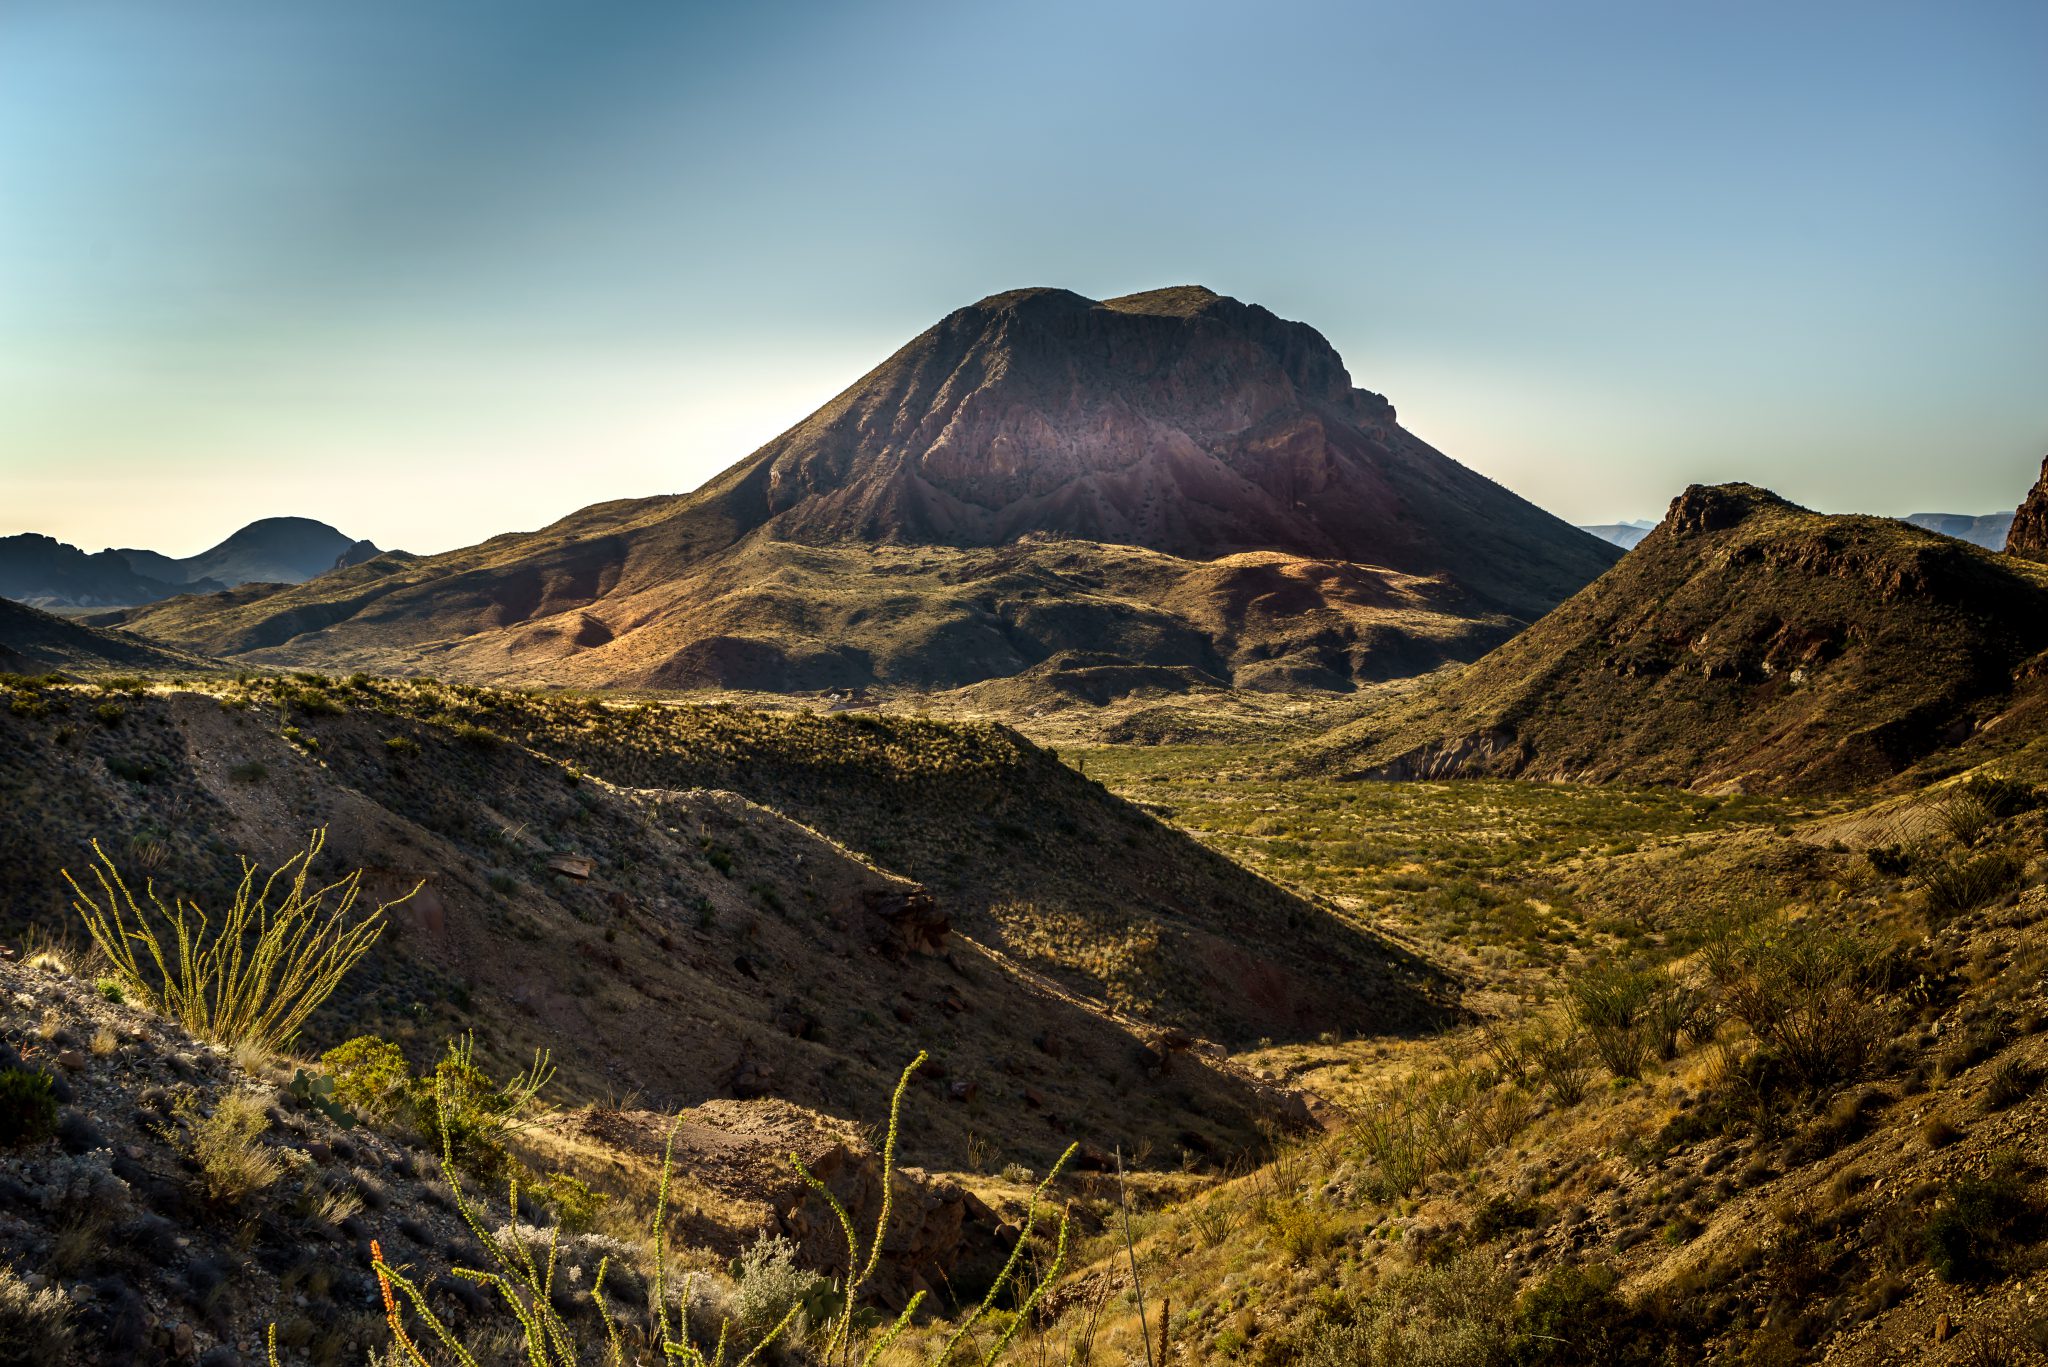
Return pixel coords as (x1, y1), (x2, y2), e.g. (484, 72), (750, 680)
(0, 516), (379, 609)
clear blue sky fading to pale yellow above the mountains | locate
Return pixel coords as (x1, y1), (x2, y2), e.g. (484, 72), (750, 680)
(0, 0), (2048, 553)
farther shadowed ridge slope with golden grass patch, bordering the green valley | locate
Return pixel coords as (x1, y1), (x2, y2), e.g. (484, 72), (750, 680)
(368, 687), (1442, 1043)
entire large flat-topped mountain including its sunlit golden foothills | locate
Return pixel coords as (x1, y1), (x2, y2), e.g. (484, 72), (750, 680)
(112, 289), (1618, 689)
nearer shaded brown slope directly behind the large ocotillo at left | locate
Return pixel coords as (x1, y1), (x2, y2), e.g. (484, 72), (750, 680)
(0, 682), (1300, 1166)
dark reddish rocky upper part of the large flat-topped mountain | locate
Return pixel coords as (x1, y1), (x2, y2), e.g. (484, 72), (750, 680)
(711, 285), (1610, 611)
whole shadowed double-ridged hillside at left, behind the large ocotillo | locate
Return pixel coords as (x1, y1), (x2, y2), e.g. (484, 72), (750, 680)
(0, 680), (1442, 1162)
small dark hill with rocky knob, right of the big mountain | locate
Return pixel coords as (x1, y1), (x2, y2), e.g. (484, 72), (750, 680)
(1294, 484), (2048, 791)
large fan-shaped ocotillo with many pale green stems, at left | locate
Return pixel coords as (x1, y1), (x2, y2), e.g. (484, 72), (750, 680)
(63, 830), (418, 1051)
